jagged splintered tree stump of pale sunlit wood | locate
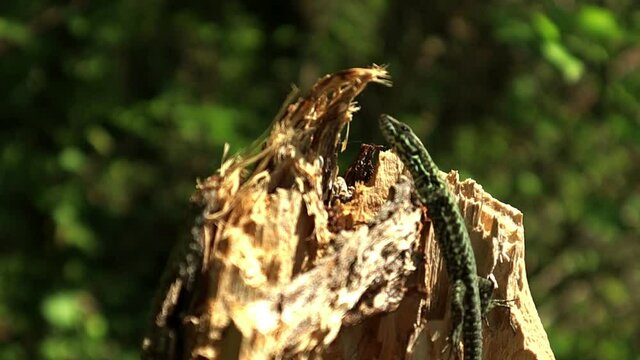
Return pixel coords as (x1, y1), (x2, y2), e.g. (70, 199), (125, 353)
(179, 66), (553, 359)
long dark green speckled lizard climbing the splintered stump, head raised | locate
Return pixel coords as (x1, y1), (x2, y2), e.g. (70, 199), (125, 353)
(379, 114), (493, 360)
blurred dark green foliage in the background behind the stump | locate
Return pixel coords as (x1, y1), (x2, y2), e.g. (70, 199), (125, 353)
(0, 0), (640, 359)
